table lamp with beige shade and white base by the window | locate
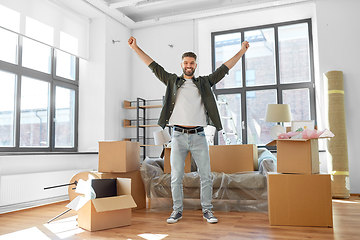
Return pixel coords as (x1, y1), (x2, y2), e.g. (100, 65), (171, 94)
(265, 104), (291, 139)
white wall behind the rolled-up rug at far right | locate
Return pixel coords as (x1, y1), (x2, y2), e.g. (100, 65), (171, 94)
(316, 0), (360, 193)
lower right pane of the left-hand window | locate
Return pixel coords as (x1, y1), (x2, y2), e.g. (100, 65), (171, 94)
(55, 87), (75, 147)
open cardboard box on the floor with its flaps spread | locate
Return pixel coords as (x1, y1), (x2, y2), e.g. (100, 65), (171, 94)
(66, 178), (136, 231)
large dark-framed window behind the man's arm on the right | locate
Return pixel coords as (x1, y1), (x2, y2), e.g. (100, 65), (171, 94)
(212, 19), (316, 145)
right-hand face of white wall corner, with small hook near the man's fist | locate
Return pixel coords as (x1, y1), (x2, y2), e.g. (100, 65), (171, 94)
(104, 17), (132, 140)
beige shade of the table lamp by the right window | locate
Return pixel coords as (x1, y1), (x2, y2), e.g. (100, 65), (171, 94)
(265, 104), (291, 122)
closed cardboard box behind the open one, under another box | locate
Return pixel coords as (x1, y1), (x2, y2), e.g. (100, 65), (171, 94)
(91, 170), (146, 209)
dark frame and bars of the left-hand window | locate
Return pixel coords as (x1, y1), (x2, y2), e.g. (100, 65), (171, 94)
(0, 29), (79, 152)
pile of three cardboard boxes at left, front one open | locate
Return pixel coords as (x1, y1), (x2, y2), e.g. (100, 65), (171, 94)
(69, 141), (146, 231)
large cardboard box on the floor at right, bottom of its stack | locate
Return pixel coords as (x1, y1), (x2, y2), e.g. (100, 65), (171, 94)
(268, 173), (333, 227)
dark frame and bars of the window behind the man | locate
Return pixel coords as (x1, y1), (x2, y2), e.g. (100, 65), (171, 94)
(211, 18), (316, 146)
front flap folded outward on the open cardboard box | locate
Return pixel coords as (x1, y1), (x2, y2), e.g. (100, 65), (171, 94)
(92, 195), (137, 212)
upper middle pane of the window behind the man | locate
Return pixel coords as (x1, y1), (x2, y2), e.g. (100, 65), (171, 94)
(245, 28), (276, 86)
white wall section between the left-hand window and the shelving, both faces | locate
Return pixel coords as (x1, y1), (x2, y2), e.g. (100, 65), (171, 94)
(79, 16), (132, 152)
